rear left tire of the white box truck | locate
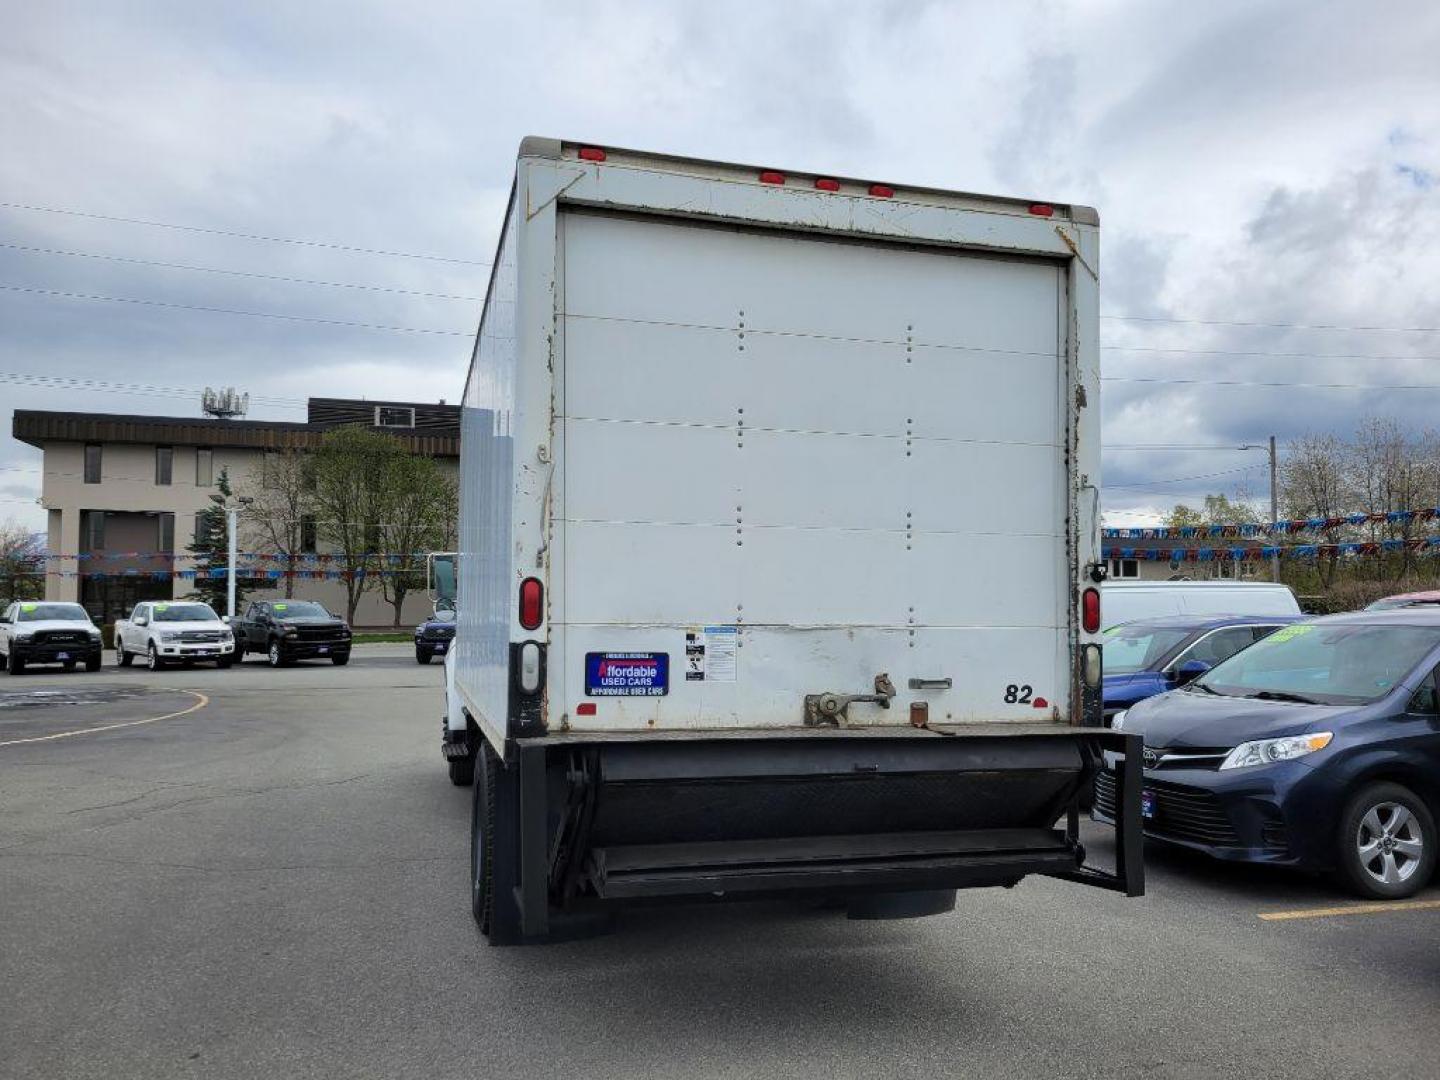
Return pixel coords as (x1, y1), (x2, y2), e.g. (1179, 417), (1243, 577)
(469, 739), (520, 945)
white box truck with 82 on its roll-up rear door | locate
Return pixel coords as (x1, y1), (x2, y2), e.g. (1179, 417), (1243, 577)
(442, 138), (1143, 943)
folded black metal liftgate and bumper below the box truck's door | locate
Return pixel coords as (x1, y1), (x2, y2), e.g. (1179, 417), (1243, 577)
(505, 726), (1143, 935)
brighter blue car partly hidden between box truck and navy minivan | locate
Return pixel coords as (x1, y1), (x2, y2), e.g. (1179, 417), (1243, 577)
(1103, 615), (1303, 723)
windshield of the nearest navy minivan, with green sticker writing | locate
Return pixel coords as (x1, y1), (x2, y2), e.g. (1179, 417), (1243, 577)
(1191, 622), (1440, 706)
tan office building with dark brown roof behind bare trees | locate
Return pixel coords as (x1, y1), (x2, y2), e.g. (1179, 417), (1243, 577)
(14, 397), (459, 626)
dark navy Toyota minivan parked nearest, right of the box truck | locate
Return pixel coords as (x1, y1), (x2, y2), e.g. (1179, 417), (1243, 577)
(1093, 608), (1440, 899)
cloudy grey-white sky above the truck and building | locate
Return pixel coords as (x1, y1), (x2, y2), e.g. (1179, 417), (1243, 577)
(0, 0), (1440, 526)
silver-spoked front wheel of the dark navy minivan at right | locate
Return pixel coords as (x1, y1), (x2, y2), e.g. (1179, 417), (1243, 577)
(1339, 783), (1440, 900)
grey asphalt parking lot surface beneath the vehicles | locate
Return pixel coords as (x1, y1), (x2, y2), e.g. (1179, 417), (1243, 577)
(0, 645), (1440, 1079)
